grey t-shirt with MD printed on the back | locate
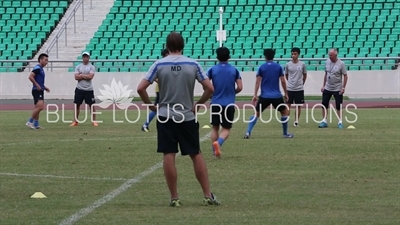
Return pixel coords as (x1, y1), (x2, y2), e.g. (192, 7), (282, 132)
(144, 55), (208, 122)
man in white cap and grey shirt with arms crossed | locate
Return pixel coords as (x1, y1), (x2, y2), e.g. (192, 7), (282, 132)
(70, 52), (98, 127)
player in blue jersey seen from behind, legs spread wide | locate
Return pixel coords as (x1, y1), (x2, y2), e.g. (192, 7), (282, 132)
(244, 49), (294, 139)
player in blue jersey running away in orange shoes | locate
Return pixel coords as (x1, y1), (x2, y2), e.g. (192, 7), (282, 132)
(207, 47), (243, 158)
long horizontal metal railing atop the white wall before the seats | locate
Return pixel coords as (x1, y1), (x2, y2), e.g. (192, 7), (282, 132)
(0, 56), (400, 72)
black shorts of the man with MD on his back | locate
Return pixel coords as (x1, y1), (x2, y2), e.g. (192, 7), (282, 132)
(157, 116), (200, 155)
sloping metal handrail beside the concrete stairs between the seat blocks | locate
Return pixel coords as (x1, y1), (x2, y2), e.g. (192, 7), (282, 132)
(44, 0), (84, 58)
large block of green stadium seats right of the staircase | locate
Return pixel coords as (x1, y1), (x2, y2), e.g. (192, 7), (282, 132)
(76, 0), (400, 72)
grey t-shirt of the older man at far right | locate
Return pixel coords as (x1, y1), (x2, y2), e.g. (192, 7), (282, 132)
(325, 59), (347, 91)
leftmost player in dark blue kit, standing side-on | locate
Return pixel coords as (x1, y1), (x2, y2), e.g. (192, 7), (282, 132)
(26, 53), (50, 129)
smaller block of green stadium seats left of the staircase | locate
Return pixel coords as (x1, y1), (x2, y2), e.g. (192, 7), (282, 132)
(0, 0), (72, 72)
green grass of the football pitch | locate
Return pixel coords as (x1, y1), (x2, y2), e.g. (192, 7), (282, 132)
(0, 109), (400, 225)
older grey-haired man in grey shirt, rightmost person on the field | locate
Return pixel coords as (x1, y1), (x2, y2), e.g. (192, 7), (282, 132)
(318, 49), (347, 128)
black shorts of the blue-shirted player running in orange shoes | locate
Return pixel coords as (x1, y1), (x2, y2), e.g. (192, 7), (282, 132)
(210, 104), (235, 129)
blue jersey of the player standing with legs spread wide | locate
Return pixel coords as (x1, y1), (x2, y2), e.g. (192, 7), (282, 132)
(257, 61), (283, 98)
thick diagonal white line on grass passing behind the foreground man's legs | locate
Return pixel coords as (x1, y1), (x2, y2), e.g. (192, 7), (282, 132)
(60, 132), (211, 225)
